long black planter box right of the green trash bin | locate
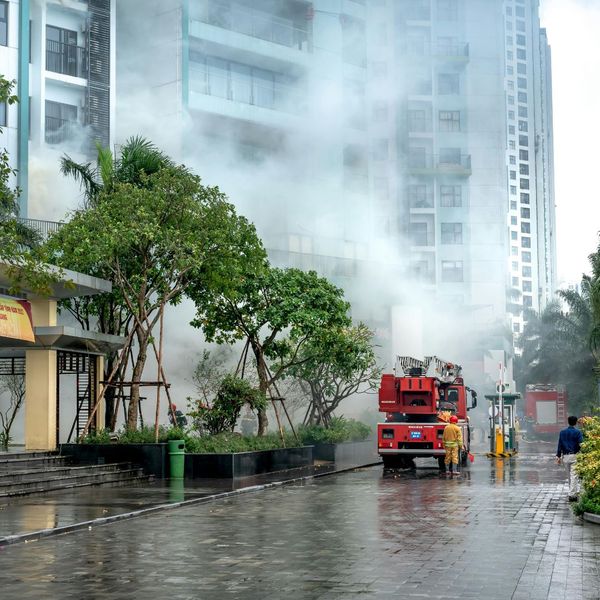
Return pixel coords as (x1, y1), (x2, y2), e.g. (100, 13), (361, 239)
(185, 446), (313, 478)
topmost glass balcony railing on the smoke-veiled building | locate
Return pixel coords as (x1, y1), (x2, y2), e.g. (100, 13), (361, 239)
(192, 2), (309, 52)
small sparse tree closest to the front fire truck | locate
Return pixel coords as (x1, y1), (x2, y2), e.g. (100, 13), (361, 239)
(290, 323), (381, 426)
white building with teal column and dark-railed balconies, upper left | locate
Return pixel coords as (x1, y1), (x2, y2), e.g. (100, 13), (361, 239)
(0, 0), (115, 218)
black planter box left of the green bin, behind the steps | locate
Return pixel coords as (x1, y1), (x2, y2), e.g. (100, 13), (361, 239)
(60, 444), (169, 478)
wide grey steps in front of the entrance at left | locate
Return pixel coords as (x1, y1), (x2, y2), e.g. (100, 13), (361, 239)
(0, 452), (149, 498)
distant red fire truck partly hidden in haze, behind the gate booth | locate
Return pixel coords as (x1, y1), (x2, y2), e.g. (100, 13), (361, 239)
(524, 383), (568, 439)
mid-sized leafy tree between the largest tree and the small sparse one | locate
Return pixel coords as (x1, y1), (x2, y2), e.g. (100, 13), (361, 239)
(191, 268), (350, 435)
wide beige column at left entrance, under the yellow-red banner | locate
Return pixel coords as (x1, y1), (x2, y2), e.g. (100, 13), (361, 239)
(25, 350), (57, 450)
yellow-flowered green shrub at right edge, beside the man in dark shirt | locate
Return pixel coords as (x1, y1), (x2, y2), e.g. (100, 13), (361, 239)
(575, 416), (600, 514)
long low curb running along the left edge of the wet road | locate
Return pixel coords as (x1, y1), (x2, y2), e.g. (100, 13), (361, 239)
(0, 462), (382, 548)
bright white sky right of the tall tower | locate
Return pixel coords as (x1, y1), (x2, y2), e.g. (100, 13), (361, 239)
(540, 0), (600, 284)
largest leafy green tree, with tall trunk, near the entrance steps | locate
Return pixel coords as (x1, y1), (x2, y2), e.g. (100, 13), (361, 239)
(48, 166), (265, 430)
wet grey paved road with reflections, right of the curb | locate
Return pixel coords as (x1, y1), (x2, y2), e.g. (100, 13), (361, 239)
(0, 453), (600, 600)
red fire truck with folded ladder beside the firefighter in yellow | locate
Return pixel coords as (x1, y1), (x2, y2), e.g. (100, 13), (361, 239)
(377, 356), (477, 469)
